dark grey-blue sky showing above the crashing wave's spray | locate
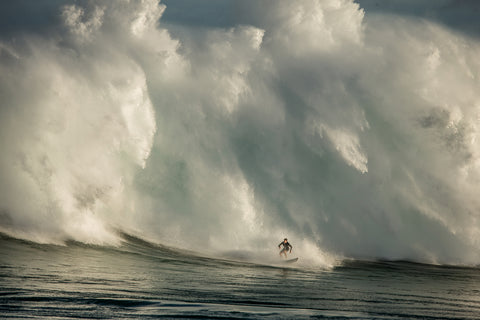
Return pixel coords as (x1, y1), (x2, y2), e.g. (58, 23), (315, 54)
(0, 0), (480, 36)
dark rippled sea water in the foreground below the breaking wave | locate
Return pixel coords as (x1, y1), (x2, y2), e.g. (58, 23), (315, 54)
(0, 232), (480, 319)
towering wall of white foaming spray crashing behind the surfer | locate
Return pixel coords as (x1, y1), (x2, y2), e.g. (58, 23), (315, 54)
(0, 0), (480, 264)
